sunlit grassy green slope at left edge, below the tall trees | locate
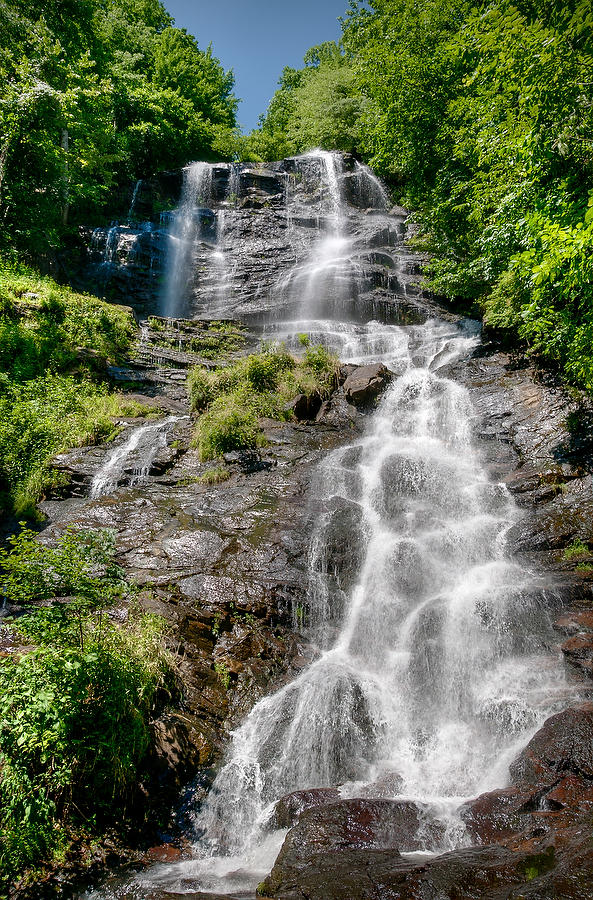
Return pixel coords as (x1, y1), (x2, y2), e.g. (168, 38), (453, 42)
(0, 268), (146, 516)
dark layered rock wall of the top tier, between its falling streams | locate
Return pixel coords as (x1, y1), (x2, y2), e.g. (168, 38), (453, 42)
(85, 156), (440, 323)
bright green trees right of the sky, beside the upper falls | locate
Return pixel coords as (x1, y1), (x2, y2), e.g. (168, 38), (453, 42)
(243, 0), (593, 390)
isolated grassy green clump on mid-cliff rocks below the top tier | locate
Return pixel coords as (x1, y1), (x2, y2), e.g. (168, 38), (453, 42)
(187, 345), (338, 459)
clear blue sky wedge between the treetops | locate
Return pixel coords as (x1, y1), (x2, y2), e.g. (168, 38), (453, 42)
(163, 0), (348, 131)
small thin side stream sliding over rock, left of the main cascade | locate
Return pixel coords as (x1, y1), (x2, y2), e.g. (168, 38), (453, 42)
(90, 416), (181, 499)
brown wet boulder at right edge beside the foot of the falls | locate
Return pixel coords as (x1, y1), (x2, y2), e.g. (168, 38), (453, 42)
(509, 702), (593, 785)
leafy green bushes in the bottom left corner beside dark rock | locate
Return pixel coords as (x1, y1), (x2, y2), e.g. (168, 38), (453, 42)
(0, 530), (170, 889)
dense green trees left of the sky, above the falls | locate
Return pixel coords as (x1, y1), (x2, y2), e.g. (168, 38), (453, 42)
(0, 0), (237, 257)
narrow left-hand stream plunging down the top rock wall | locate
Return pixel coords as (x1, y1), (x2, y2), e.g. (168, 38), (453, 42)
(163, 162), (212, 318)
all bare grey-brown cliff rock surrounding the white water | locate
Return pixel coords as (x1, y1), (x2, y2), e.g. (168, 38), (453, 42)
(33, 156), (593, 900)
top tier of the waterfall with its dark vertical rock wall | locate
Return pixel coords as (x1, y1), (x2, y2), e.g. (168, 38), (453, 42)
(87, 150), (417, 322)
